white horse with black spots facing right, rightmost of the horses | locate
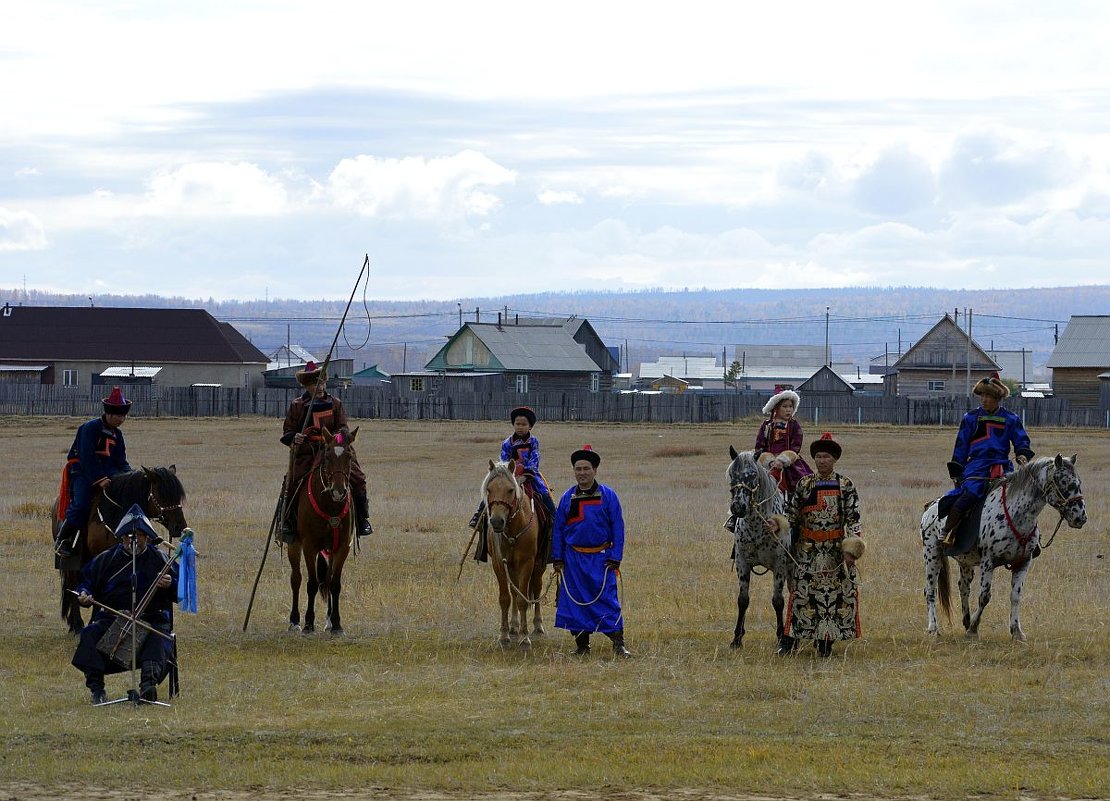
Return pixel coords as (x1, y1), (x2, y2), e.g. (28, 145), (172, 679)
(921, 454), (1087, 642)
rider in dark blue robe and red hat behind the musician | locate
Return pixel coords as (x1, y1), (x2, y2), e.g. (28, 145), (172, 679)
(54, 386), (131, 559)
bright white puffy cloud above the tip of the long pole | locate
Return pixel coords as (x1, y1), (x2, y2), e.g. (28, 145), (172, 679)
(326, 150), (516, 221)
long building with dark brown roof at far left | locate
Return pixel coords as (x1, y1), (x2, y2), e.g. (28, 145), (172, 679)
(0, 304), (269, 388)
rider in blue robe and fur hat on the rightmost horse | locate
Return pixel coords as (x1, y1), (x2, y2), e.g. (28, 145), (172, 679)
(940, 373), (1033, 546)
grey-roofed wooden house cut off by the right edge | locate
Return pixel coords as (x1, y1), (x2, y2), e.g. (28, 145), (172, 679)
(1046, 315), (1110, 408)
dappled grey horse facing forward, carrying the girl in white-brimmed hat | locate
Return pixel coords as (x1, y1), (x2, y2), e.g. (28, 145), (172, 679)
(725, 446), (790, 648)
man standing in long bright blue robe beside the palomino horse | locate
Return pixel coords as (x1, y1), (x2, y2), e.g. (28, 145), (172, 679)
(552, 445), (632, 657)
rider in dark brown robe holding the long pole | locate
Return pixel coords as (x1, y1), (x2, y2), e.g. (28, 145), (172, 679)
(280, 362), (374, 544)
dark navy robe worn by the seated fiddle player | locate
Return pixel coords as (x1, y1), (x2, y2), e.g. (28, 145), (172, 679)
(73, 545), (178, 681)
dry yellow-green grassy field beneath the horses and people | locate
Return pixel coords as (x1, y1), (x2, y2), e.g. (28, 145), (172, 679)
(0, 418), (1110, 799)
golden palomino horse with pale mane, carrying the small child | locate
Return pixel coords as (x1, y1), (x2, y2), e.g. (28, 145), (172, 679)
(482, 459), (547, 648)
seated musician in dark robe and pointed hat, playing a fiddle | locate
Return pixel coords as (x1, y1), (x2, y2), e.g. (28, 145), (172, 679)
(72, 507), (178, 703)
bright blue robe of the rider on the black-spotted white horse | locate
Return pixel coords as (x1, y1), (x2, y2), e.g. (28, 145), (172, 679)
(946, 406), (1033, 498)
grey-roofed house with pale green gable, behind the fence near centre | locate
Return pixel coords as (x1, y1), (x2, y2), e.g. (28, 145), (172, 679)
(424, 315), (618, 395)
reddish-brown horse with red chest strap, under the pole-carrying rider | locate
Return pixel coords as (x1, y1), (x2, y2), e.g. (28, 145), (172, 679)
(289, 428), (359, 635)
